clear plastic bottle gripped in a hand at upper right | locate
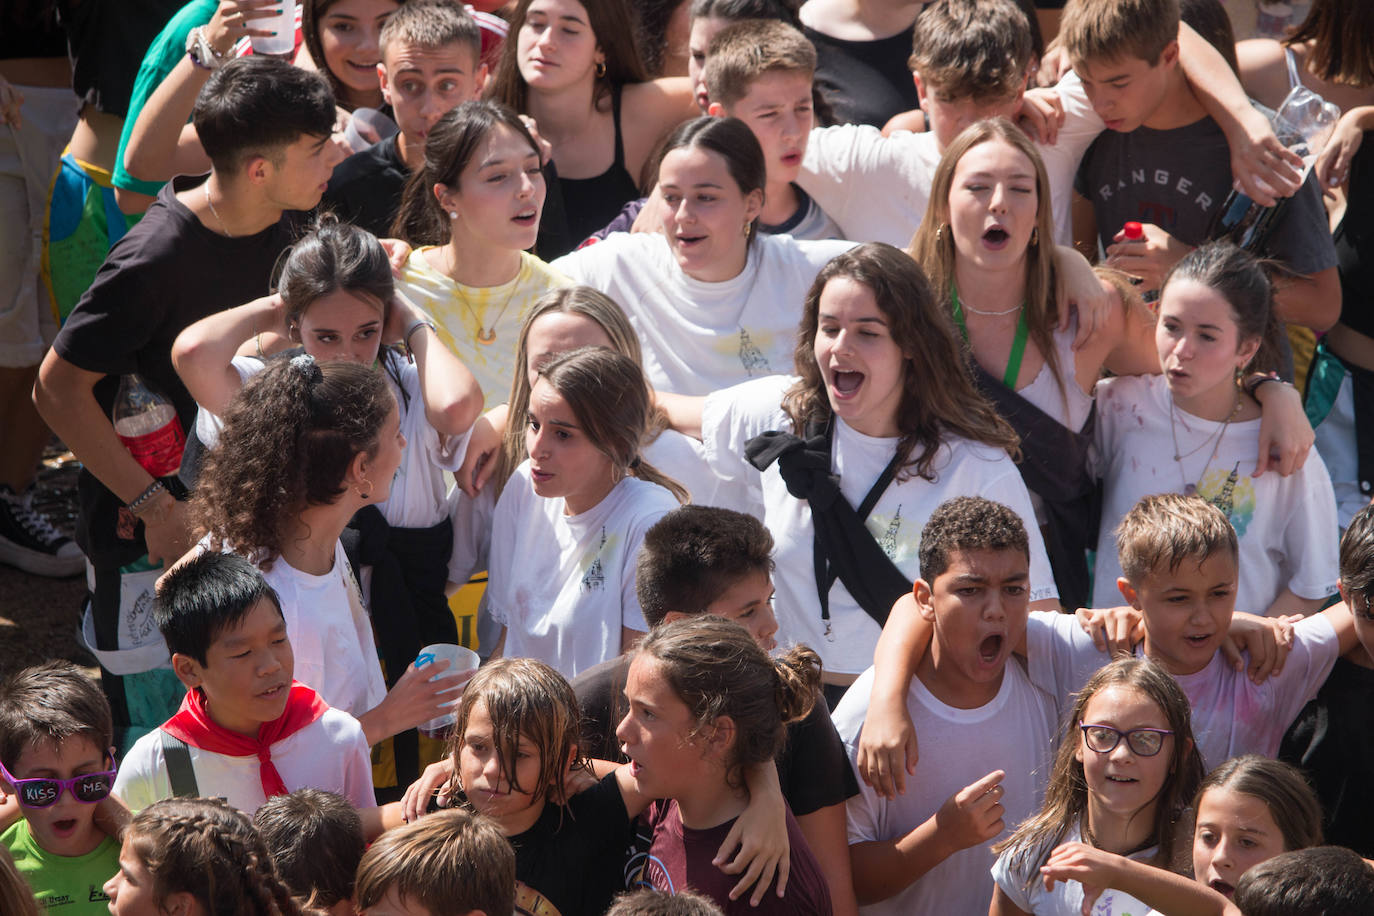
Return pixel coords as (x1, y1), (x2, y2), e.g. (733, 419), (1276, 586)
(1206, 87), (1341, 254)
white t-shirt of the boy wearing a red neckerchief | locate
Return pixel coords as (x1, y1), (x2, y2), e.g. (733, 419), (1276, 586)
(114, 709), (376, 816)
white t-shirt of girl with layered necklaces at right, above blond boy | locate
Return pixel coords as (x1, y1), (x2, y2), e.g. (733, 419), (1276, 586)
(1092, 375), (1340, 614)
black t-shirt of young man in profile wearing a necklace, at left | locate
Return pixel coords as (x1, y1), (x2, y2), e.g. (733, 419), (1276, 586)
(52, 177), (302, 569)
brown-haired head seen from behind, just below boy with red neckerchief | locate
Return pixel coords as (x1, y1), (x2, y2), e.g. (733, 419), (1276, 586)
(253, 788), (367, 916)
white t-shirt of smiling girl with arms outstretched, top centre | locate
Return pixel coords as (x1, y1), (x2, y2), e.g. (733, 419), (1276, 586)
(551, 232), (853, 396)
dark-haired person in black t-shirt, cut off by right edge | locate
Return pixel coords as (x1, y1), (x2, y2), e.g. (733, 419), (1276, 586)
(1279, 497), (1374, 858)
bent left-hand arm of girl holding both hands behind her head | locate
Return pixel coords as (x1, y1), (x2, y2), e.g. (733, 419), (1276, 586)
(172, 294), (286, 416)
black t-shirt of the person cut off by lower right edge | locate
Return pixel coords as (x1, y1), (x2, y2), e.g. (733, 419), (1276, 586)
(1279, 658), (1374, 858)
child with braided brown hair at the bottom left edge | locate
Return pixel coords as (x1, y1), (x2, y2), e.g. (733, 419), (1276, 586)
(104, 798), (309, 916)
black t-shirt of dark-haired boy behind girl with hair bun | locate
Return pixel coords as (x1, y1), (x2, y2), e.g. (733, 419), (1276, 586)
(573, 655), (859, 817)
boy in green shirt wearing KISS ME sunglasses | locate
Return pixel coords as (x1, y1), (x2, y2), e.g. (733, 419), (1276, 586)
(0, 662), (120, 915)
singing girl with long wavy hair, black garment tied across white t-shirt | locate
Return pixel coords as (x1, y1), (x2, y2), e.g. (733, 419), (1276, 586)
(660, 243), (1055, 695)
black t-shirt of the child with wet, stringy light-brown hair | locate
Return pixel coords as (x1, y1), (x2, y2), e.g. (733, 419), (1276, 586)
(460, 773), (635, 916)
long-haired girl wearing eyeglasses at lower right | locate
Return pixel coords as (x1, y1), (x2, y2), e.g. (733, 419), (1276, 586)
(989, 658), (1202, 916)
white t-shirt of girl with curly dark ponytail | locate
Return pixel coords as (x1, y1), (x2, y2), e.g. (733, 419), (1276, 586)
(262, 542), (386, 715)
